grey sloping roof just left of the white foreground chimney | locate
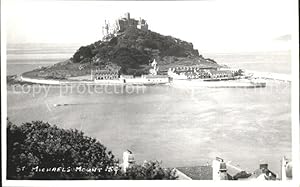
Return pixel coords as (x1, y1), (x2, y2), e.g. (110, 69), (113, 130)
(176, 165), (213, 180)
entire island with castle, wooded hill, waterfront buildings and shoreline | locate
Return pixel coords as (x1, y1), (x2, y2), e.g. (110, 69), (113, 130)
(20, 13), (265, 87)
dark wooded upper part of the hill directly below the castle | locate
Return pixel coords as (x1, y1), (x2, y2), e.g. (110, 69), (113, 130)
(72, 28), (216, 73)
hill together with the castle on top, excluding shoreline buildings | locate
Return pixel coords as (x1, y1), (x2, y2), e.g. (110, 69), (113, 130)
(22, 13), (219, 79)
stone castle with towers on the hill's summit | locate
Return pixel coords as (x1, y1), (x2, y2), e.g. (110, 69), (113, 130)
(102, 12), (148, 40)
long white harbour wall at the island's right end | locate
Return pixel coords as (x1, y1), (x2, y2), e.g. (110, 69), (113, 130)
(171, 79), (266, 88)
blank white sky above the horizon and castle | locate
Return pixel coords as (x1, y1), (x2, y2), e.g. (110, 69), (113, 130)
(4, 0), (297, 52)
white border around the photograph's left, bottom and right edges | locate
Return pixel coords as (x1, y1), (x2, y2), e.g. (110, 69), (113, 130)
(1, 0), (300, 187)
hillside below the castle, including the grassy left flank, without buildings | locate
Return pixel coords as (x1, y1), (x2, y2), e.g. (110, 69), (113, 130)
(22, 25), (218, 77)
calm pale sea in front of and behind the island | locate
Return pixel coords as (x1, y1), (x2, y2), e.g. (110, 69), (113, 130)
(7, 43), (291, 173)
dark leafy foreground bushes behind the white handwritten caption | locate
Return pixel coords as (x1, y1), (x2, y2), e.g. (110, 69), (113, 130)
(7, 121), (176, 179)
